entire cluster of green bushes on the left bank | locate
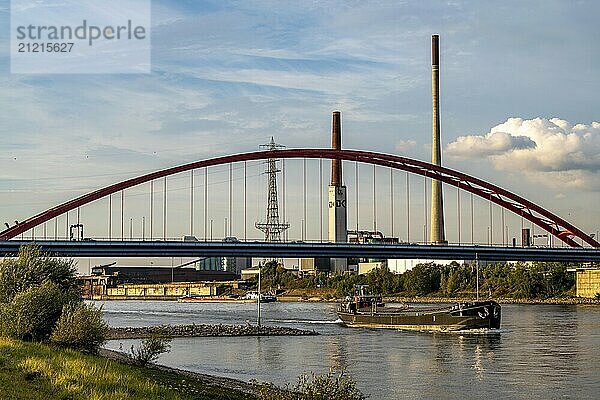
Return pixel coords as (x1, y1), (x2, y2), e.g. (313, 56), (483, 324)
(0, 246), (107, 352)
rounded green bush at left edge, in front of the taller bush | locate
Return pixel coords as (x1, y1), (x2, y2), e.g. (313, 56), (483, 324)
(2, 282), (65, 341)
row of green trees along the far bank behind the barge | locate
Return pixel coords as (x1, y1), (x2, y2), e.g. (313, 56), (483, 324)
(261, 261), (575, 299)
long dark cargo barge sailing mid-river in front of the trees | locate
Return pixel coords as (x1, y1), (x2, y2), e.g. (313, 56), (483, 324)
(337, 287), (501, 332)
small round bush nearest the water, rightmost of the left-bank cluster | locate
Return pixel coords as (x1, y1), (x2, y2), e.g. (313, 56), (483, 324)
(50, 302), (108, 354)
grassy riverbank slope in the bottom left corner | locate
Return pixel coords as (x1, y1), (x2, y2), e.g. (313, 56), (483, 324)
(0, 338), (254, 400)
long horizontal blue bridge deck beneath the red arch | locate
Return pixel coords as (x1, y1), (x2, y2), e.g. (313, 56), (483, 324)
(0, 240), (600, 262)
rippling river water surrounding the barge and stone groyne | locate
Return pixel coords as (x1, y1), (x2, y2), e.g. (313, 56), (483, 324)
(99, 301), (600, 399)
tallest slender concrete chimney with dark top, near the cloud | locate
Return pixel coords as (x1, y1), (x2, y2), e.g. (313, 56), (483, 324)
(430, 35), (448, 244)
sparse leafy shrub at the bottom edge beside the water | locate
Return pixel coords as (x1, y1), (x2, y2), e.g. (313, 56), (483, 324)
(254, 369), (366, 400)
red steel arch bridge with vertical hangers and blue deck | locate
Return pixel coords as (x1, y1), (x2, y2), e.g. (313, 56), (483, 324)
(0, 149), (600, 261)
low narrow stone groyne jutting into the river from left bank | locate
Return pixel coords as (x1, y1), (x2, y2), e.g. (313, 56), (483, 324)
(107, 324), (318, 340)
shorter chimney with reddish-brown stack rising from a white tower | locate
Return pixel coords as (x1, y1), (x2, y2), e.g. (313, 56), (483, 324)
(328, 111), (348, 271)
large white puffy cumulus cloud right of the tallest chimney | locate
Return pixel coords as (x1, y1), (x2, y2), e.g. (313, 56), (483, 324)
(446, 118), (600, 189)
